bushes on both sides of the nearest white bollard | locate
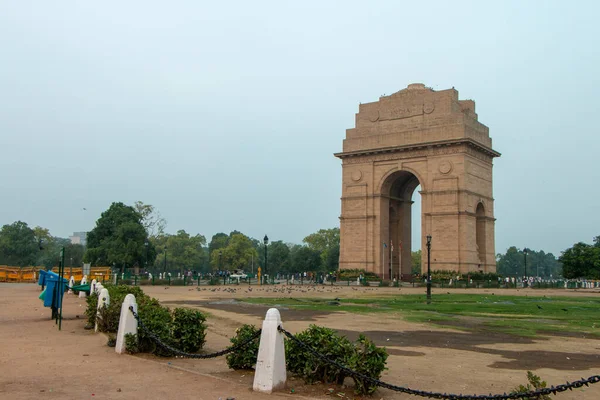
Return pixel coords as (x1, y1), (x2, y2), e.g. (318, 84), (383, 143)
(227, 325), (388, 394)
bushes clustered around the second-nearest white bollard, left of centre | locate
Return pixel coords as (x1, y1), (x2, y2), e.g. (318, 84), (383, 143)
(85, 285), (206, 356)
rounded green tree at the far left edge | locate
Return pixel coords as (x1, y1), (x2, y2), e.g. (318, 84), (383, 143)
(0, 221), (40, 267)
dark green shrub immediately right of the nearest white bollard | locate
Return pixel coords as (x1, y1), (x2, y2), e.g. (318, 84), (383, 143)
(285, 325), (353, 384)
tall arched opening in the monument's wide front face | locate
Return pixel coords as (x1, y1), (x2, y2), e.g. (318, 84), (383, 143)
(380, 171), (422, 280)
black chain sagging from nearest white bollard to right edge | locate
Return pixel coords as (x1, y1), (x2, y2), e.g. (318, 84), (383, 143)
(277, 326), (600, 400)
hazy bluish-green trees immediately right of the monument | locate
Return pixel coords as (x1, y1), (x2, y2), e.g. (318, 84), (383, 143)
(496, 246), (562, 278)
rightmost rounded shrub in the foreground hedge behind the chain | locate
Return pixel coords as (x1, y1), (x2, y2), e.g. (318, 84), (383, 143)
(346, 334), (388, 394)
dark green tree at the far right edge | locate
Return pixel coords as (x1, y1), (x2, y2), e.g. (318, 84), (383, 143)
(559, 236), (600, 279)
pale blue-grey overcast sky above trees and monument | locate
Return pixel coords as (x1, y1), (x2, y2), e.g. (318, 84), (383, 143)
(0, 0), (600, 254)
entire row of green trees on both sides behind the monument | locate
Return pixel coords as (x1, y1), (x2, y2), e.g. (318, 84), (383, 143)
(0, 201), (600, 279)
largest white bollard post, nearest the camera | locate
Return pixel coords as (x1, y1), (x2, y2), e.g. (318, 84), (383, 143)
(253, 308), (287, 393)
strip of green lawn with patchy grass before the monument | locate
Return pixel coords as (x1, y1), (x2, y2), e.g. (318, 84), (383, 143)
(244, 294), (600, 338)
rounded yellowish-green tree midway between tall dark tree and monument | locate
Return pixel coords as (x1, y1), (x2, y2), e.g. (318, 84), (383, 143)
(210, 233), (258, 270)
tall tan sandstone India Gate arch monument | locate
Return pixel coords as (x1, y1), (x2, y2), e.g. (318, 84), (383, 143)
(335, 84), (500, 280)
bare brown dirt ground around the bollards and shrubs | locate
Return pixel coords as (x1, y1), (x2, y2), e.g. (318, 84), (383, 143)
(0, 284), (600, 400)
